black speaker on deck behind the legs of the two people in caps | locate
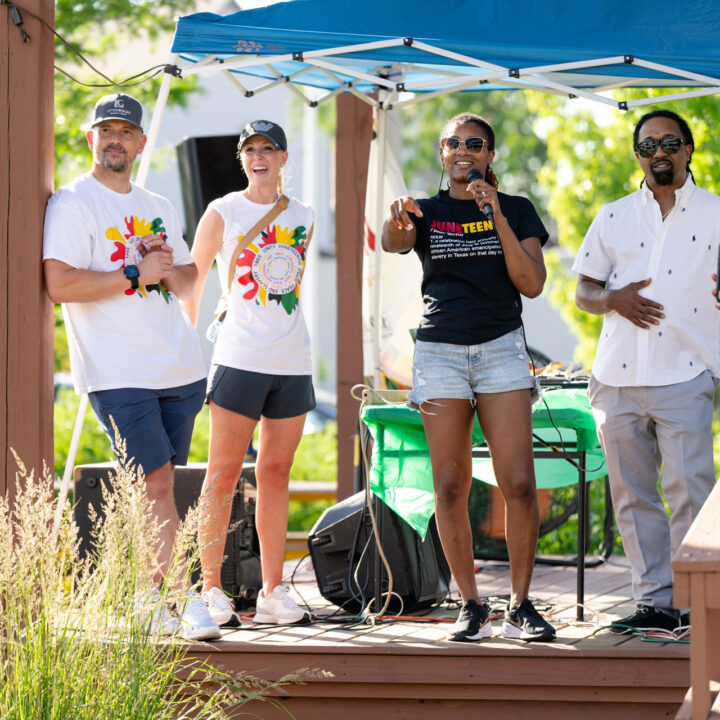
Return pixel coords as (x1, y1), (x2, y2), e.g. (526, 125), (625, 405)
(73, 463), (262, 609)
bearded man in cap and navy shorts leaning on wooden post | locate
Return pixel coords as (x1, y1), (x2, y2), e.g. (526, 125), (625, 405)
(43, 94), (220, 639)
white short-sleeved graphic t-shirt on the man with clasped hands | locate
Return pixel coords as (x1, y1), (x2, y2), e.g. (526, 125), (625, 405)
(43, 173), (205, 393)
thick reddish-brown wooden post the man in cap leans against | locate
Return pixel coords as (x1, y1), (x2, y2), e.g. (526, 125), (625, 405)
(0, 0), (54, 499)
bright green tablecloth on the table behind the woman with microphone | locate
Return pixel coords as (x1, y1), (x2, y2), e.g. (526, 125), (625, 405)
(360, 389), (607, 538)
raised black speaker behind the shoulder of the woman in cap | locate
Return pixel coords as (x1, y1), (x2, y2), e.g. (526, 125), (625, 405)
(176, 135), (248, 247)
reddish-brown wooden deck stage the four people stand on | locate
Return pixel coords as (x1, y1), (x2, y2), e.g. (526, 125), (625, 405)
(184, 557), (690, 720)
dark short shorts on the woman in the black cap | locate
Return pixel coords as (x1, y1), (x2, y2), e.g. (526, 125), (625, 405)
(207, 365), (316, 420)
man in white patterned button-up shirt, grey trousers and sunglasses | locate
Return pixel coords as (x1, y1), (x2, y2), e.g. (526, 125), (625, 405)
(573, 110), (720, 632)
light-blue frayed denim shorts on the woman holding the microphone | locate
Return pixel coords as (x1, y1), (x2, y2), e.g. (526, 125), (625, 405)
(410, 329), (537, 406)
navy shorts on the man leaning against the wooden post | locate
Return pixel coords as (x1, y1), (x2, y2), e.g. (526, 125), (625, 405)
(88, 380), (206, 475)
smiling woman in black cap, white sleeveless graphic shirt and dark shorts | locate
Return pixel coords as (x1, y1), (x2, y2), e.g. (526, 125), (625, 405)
(186, 120), (315, 625)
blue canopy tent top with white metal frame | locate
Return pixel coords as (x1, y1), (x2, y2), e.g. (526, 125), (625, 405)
(153, 0), (720, 106)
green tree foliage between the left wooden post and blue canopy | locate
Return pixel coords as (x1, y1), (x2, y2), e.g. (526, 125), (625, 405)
(55, 0), (198, 186)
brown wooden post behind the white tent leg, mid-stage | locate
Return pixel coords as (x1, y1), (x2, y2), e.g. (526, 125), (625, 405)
(335, 93), (372, 500)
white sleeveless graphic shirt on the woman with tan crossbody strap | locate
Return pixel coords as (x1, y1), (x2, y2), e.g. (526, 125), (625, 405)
(208, 192), (314, 375)
